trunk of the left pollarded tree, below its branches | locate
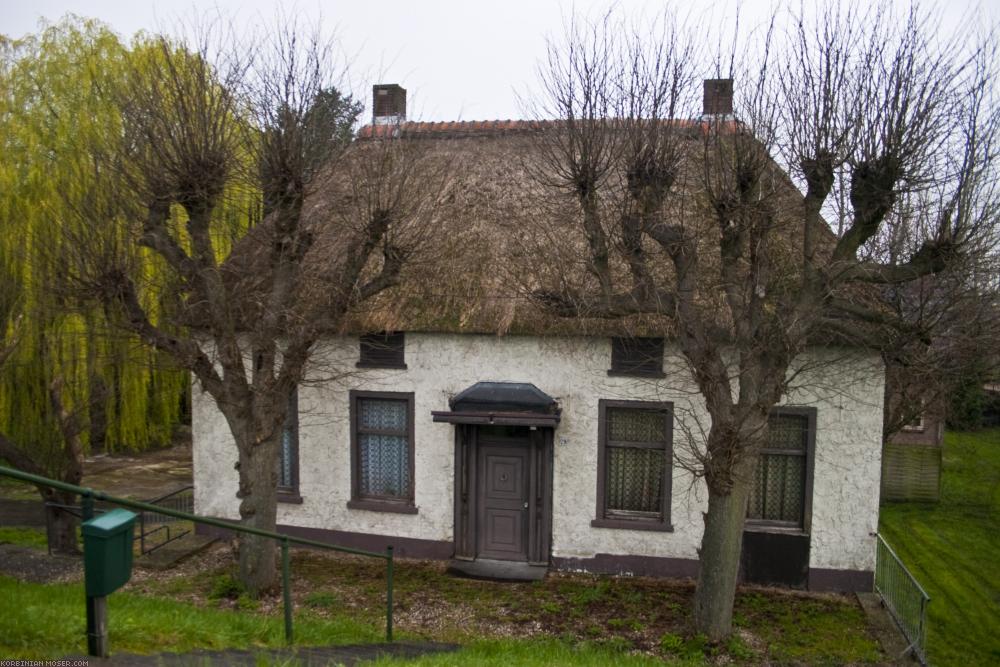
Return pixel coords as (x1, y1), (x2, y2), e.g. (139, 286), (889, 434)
(237, 428), (280, 596)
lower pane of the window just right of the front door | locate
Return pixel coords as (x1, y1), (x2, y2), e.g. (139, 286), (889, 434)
(606, 447), (664, 514)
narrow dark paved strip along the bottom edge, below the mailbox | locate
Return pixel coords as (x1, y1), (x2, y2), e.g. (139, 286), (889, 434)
(74, 642), (459, 667)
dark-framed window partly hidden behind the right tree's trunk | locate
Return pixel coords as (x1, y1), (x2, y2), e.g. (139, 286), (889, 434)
(747, 409), (816, 529)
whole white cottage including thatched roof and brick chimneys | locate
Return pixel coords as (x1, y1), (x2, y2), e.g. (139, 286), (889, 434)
(192, 86), (885, 590)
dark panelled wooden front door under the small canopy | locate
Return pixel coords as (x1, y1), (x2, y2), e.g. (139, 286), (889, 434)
(478, 439), (530, 561)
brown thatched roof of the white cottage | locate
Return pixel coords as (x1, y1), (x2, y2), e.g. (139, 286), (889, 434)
(219, 121), (836, 335)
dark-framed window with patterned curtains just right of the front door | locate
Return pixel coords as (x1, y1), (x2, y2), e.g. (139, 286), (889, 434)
(591, 400), (673, 530)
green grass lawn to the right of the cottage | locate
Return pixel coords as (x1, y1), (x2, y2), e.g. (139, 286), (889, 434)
(880, 429), (1000, 665)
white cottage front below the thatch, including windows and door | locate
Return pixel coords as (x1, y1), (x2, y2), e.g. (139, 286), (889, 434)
(192, 332), (883, 590)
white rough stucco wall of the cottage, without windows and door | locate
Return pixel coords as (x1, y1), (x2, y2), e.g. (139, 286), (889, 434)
(192, 333), (884, 570)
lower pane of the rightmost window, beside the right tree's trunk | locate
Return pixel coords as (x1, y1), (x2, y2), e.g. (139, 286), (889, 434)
(747, 454), (805, 525)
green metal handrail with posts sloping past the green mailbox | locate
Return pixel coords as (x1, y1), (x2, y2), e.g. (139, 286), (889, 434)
(0, 466), (393, 644)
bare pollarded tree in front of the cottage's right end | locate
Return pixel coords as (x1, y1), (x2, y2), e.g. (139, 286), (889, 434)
(534, 4), (1000, 639)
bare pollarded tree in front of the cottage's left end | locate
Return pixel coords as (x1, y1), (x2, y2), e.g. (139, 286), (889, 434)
(58, 26), (448, 594)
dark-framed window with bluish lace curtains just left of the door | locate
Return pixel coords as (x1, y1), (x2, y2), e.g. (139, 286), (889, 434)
(348, 391), (416, 514)
